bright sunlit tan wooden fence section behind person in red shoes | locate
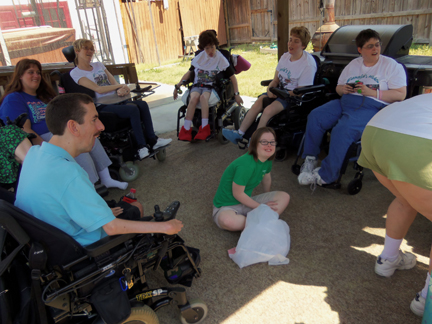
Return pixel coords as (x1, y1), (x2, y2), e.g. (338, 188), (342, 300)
(119, 0), (226, 64)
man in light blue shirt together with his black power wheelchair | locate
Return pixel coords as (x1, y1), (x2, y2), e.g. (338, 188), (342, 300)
(0, 94), (206, 323)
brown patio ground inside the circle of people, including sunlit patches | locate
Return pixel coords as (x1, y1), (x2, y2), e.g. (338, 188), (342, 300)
(109, 132), (432, 324)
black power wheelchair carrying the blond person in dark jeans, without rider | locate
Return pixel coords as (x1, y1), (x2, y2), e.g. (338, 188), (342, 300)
(52, 46), (166, 182)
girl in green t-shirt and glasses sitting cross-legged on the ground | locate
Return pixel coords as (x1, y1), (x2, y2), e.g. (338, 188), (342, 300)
(213, 127), (290, 231)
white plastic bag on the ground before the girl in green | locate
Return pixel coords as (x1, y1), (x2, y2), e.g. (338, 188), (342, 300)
(229, 204), (291, 268)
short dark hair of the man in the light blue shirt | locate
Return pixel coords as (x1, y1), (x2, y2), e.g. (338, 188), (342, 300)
(45, 93), (93, 136)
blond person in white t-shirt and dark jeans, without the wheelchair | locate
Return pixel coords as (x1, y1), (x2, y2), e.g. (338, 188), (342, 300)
(70, 38), (171, 159)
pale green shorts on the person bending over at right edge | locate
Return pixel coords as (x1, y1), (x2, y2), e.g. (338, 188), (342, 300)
(358, 126), (432, 190)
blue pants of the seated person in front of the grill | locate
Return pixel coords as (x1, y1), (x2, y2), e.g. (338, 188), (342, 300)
(302, 95), (386, 183)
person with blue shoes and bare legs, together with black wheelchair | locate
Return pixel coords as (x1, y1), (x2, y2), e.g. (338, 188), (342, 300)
(222, 26), (321, 159)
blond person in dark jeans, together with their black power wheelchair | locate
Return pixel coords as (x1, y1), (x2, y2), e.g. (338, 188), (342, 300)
(60, 39), (171, 181)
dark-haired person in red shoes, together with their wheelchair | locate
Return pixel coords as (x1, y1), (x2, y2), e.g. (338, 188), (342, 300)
(173, 30), (246, 144)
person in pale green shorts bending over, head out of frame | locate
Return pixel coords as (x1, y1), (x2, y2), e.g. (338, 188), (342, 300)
(358, 94), (432, 316)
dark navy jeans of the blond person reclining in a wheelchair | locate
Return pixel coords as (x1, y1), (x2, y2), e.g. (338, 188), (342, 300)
(97, 100), (156, 148)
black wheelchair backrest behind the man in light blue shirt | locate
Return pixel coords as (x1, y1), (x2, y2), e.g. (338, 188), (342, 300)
(0, 200), (87, 266)
